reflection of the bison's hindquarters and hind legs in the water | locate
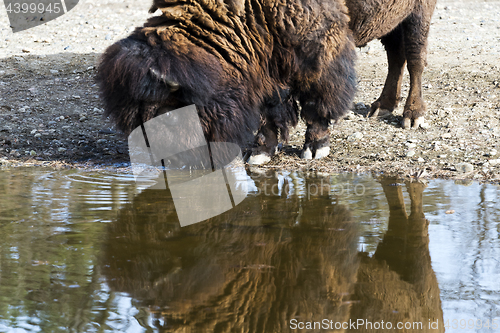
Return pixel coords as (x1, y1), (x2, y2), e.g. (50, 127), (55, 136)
(351, 179), (444, 332)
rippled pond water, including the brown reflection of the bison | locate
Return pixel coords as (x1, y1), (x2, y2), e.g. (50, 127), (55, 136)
(0, 169), (500, 332)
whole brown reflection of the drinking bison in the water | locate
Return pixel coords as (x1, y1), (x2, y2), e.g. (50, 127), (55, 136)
(103, 172), (442, 332)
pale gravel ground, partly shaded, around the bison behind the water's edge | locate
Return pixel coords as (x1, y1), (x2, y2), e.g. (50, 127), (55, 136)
(0, 0), (500, 183)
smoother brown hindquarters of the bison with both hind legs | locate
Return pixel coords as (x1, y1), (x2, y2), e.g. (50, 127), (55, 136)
(346, 0), (436, 128)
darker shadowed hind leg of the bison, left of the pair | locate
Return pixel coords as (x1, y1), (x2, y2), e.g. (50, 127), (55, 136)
(368, 25), (406, 117)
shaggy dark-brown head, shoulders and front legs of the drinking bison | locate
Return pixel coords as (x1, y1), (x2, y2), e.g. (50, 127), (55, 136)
(98, 0), (355, 154)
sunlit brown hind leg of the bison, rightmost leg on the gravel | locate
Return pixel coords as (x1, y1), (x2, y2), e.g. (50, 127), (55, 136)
(402, 7), (434, 128)
